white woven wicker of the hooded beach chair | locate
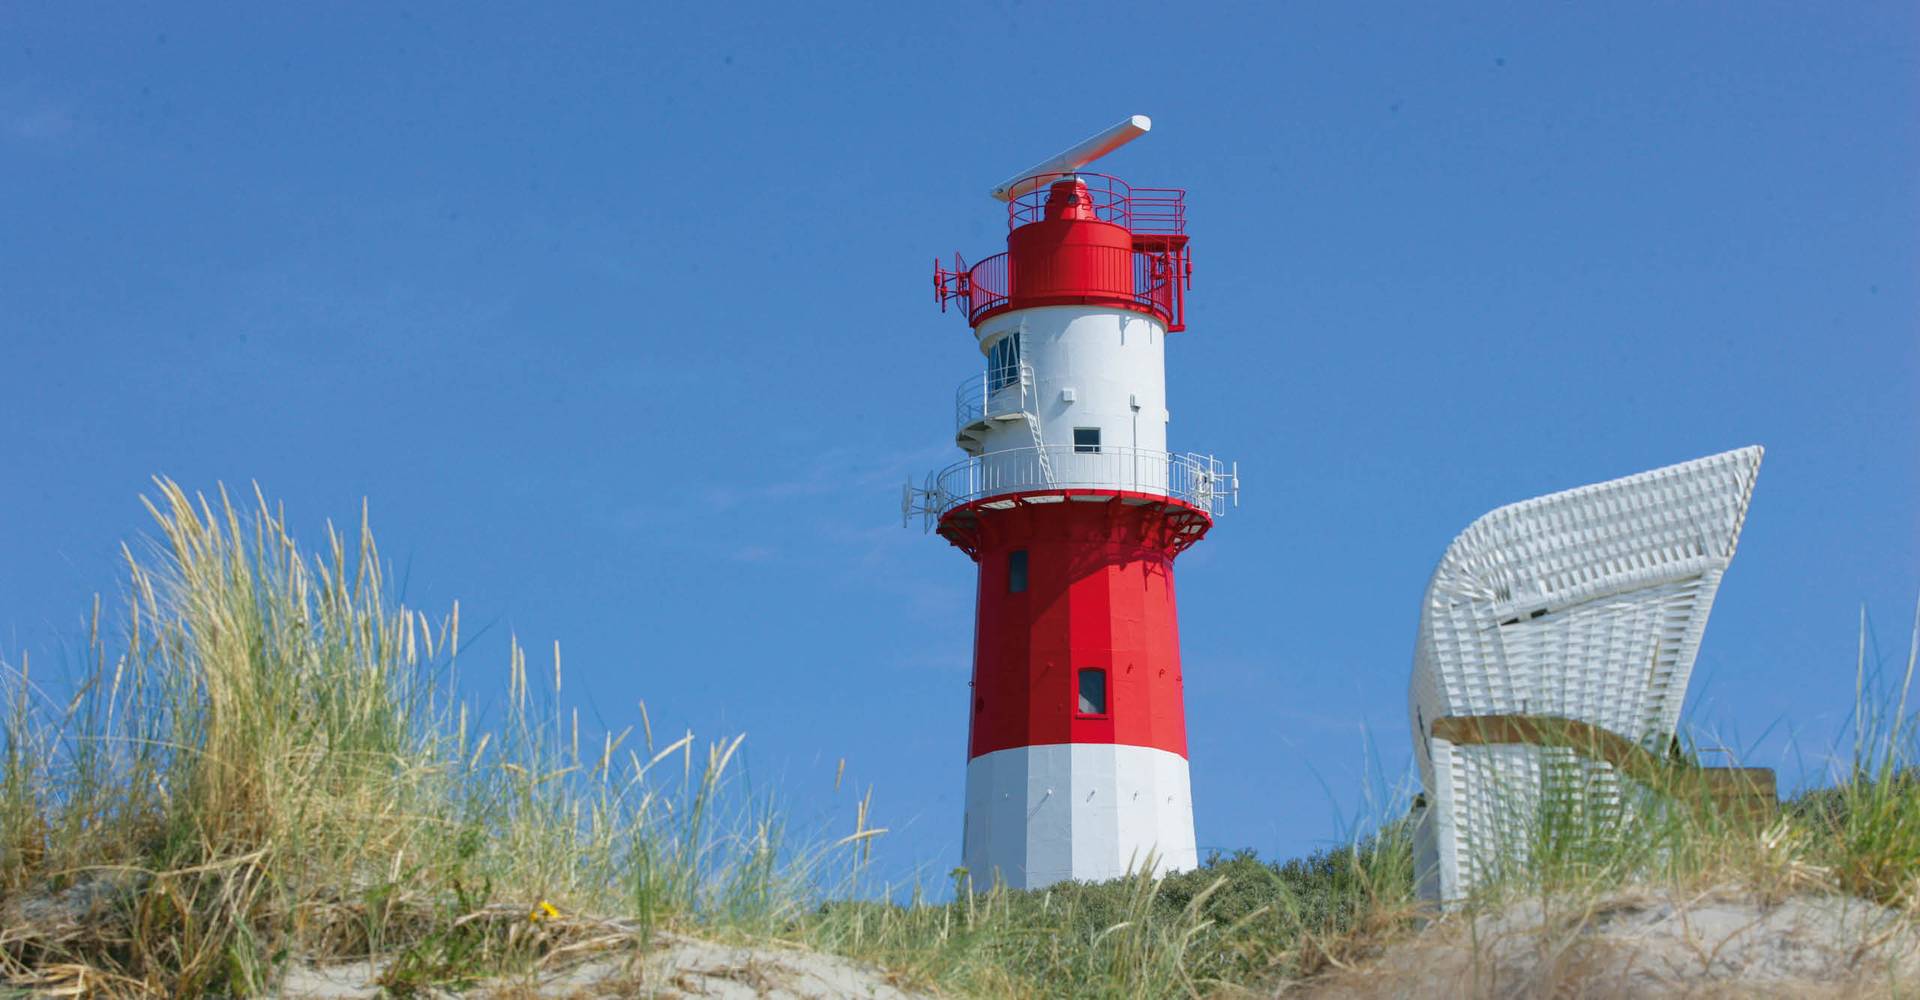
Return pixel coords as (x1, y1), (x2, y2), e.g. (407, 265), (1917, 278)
(1407, 447), (1761, 898)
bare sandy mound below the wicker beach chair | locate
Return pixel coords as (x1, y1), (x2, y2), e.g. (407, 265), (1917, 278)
(1283, 889), (1920, 1000)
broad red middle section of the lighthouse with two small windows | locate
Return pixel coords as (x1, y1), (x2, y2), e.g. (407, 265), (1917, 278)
(941, 491), (1212, 758)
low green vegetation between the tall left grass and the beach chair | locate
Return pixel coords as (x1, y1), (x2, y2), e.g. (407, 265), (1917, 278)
(804, 827), (1413, 996)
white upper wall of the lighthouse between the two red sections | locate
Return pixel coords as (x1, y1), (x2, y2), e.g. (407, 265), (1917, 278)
(975, 305), (1167, 460)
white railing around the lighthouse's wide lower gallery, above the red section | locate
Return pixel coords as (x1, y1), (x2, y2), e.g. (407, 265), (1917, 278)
(906, 445), (1240, 522)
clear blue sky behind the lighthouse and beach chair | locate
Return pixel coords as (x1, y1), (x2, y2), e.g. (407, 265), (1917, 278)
(0, 4), (1920, 877)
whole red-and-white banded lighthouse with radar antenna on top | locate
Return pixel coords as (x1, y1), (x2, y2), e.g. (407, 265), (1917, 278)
(902, 115), (1238, 889)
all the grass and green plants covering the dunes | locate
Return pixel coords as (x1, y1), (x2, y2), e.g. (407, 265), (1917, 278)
(0, 482), (1920, 996)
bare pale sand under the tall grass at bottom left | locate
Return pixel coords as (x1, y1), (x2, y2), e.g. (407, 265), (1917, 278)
(278, 937), (925, 1000)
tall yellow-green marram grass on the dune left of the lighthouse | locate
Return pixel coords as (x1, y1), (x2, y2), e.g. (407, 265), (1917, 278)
(0, 480), (814, 996)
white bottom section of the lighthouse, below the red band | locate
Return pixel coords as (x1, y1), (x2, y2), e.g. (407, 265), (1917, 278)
(960, 743), (1198, 889)
